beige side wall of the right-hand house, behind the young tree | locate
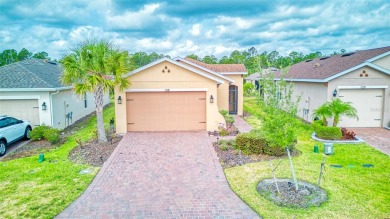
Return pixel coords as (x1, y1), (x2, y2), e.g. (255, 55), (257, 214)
(293, 82), (327, 121)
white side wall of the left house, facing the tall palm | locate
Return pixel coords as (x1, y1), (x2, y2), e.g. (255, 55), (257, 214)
(49, 89), (110, 129)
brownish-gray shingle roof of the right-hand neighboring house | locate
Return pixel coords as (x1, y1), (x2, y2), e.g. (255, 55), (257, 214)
(285, 46), (390, 80)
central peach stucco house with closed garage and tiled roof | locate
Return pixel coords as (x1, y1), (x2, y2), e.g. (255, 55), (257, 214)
(115, 58), (247, 133)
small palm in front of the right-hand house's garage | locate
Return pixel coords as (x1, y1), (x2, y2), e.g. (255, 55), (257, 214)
(329, 98), (359, 127)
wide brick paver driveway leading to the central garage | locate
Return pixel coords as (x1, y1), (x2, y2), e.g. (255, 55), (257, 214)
(58, 132), (259, 218)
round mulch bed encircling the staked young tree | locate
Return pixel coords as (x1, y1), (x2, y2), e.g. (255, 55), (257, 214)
(256, 179), (328, 208)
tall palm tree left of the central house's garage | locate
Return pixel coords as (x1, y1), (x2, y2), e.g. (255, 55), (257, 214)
(60, 40), (130, 142)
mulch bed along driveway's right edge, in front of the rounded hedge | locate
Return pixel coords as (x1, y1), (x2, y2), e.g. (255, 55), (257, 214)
(213, 142), (301, 169)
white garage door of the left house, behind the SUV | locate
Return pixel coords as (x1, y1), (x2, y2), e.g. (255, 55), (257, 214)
(0, 100), (40, 126)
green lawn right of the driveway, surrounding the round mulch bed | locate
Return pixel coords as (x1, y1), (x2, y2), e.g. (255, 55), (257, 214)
(225, 98), (390, 218)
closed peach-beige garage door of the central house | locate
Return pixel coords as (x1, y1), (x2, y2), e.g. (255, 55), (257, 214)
(126, 92), (206, 131)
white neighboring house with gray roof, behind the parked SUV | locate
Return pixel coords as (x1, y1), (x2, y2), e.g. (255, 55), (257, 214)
(0, 59), (109, 129)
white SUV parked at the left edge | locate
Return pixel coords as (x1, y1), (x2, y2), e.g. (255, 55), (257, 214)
(0, 116), (31, 157)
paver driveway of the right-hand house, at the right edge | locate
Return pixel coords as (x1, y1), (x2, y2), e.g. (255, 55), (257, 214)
(350, 128), (390, 155)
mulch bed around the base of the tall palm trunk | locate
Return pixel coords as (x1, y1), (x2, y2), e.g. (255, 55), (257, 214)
(69, 136), (122, 167)
